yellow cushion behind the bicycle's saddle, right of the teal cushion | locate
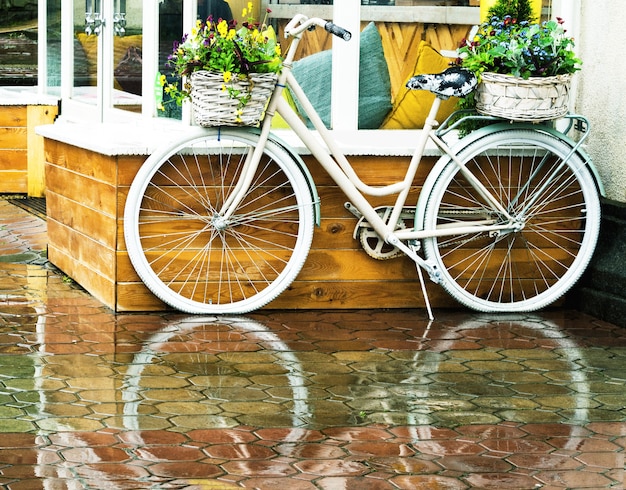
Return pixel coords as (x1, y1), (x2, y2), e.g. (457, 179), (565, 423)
(381, 41), (458, 129)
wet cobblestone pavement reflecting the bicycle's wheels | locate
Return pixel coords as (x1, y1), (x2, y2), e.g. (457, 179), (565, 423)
(0, 201), (626, 490)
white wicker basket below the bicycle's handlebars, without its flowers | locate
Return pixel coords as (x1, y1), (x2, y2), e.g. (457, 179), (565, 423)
(189, 71), (278, 127)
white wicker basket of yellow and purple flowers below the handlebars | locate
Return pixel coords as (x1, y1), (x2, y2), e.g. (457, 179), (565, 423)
(161, 2), (282, 126)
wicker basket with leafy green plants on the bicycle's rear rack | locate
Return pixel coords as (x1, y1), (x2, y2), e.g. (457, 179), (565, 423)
(459, 15), (581, 121)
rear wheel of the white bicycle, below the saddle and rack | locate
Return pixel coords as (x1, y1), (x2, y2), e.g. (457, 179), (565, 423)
(424, 129), (600, 312)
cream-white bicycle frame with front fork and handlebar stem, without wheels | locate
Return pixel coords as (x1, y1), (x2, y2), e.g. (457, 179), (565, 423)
(222, 16), (528, 283)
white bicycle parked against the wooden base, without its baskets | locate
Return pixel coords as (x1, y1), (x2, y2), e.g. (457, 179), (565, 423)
(124, 15), (602, 317)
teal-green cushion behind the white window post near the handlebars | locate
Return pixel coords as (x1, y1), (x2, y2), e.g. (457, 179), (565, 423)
(293, 22), (391, 129)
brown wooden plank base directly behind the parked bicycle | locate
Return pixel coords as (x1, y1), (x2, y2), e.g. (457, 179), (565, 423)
(39, 124), (452, 312)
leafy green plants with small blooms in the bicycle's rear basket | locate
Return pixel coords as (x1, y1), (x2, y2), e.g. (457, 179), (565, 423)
(458, 15), (581, 79)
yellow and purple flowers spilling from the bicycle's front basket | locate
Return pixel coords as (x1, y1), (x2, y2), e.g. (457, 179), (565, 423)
(160, 2), (282, 111)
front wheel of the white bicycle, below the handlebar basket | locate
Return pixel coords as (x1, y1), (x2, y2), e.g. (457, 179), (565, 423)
(124, 129), (315, 314)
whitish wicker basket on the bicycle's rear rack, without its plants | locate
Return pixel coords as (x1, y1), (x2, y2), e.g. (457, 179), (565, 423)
(476, 72), (572, 122)
